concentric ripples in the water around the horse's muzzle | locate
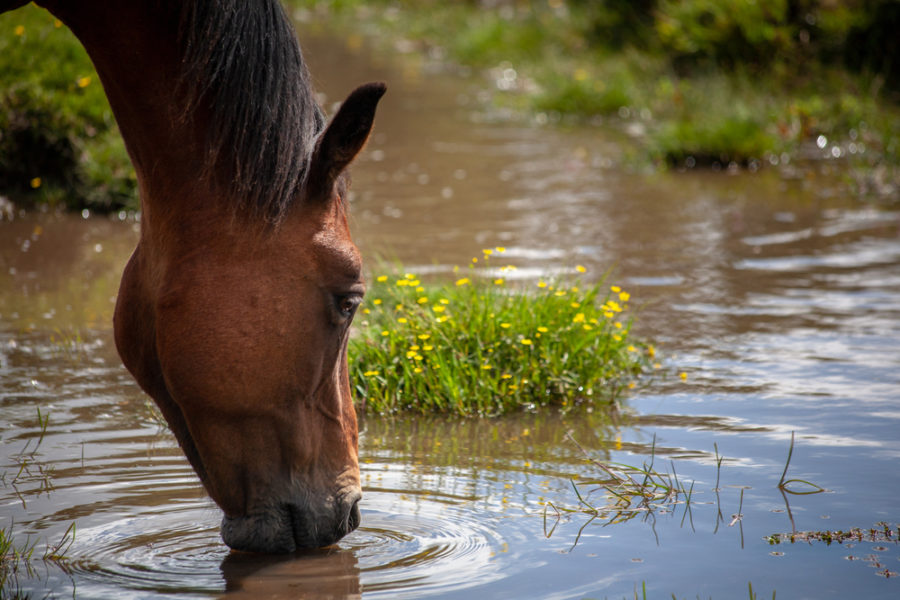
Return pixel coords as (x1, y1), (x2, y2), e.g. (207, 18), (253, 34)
(58, 491), (510, 598)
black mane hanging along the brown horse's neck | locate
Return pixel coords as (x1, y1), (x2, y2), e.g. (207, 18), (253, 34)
(179, 0), (325, 223)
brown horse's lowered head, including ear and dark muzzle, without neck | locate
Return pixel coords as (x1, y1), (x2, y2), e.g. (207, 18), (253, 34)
(116, 84), (384, 552)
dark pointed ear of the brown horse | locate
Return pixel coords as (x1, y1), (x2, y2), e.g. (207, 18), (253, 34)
(306, 83), (387, 198)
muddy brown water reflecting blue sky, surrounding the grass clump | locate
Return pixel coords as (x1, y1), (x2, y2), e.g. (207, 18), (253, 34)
(0, 25), (900, 598)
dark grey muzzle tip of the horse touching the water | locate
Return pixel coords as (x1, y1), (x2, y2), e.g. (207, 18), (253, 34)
(221, 491), (362, 554)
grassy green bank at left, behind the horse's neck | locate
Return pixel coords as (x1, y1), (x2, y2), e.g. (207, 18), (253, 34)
(0, 5), (137, 211)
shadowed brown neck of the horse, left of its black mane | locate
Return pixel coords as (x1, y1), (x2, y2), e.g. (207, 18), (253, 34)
(41, 0), (209, 212)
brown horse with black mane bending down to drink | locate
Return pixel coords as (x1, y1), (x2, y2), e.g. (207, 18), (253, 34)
(0, 0), (384, 552)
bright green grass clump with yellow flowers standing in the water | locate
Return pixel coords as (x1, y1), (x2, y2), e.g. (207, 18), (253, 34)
(349, 249), (654, 416)
